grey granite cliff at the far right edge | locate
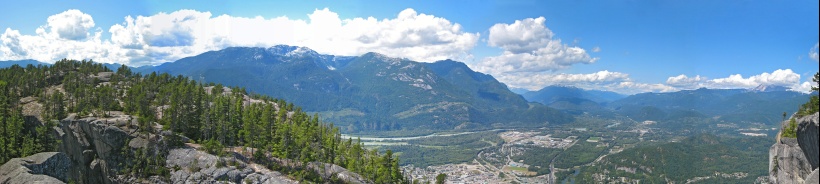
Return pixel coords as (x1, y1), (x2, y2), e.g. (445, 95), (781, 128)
(769, 113), (820, 183)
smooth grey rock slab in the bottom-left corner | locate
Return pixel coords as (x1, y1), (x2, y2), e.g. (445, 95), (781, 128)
(0, 152), (71, 184)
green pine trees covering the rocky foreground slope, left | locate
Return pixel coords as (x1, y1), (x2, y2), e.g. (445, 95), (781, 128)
(0, 60), (404, 183)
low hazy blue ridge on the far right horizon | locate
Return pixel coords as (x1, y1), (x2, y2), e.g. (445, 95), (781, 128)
(607, 88), (816, 123)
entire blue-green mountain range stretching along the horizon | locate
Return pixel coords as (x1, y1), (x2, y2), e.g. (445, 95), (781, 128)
(0, 45), (809, 134)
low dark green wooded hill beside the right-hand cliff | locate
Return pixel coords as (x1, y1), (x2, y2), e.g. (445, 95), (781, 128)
(575, 134), (772, 183)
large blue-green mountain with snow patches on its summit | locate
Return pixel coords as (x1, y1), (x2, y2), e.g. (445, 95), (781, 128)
(143, 45), (572, 132)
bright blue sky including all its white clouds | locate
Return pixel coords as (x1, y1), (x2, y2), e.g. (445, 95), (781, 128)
(0, 0), (820, 94)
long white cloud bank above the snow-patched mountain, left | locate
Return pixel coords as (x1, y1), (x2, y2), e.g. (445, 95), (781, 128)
(0, 8), (480, 66)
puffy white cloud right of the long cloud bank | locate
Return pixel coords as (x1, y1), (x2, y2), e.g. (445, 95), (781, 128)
(470, 17), (600, 90)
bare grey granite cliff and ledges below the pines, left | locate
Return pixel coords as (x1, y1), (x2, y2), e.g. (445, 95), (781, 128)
(0, 112), (369, 183)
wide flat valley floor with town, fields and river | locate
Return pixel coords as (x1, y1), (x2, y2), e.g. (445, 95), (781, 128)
(346, 113), (777, 183)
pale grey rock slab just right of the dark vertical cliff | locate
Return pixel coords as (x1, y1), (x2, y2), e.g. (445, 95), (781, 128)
(166, 148), (298, 183)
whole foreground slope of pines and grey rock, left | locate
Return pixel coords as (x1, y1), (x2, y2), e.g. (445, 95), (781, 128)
(0, 60), (406, 183)
